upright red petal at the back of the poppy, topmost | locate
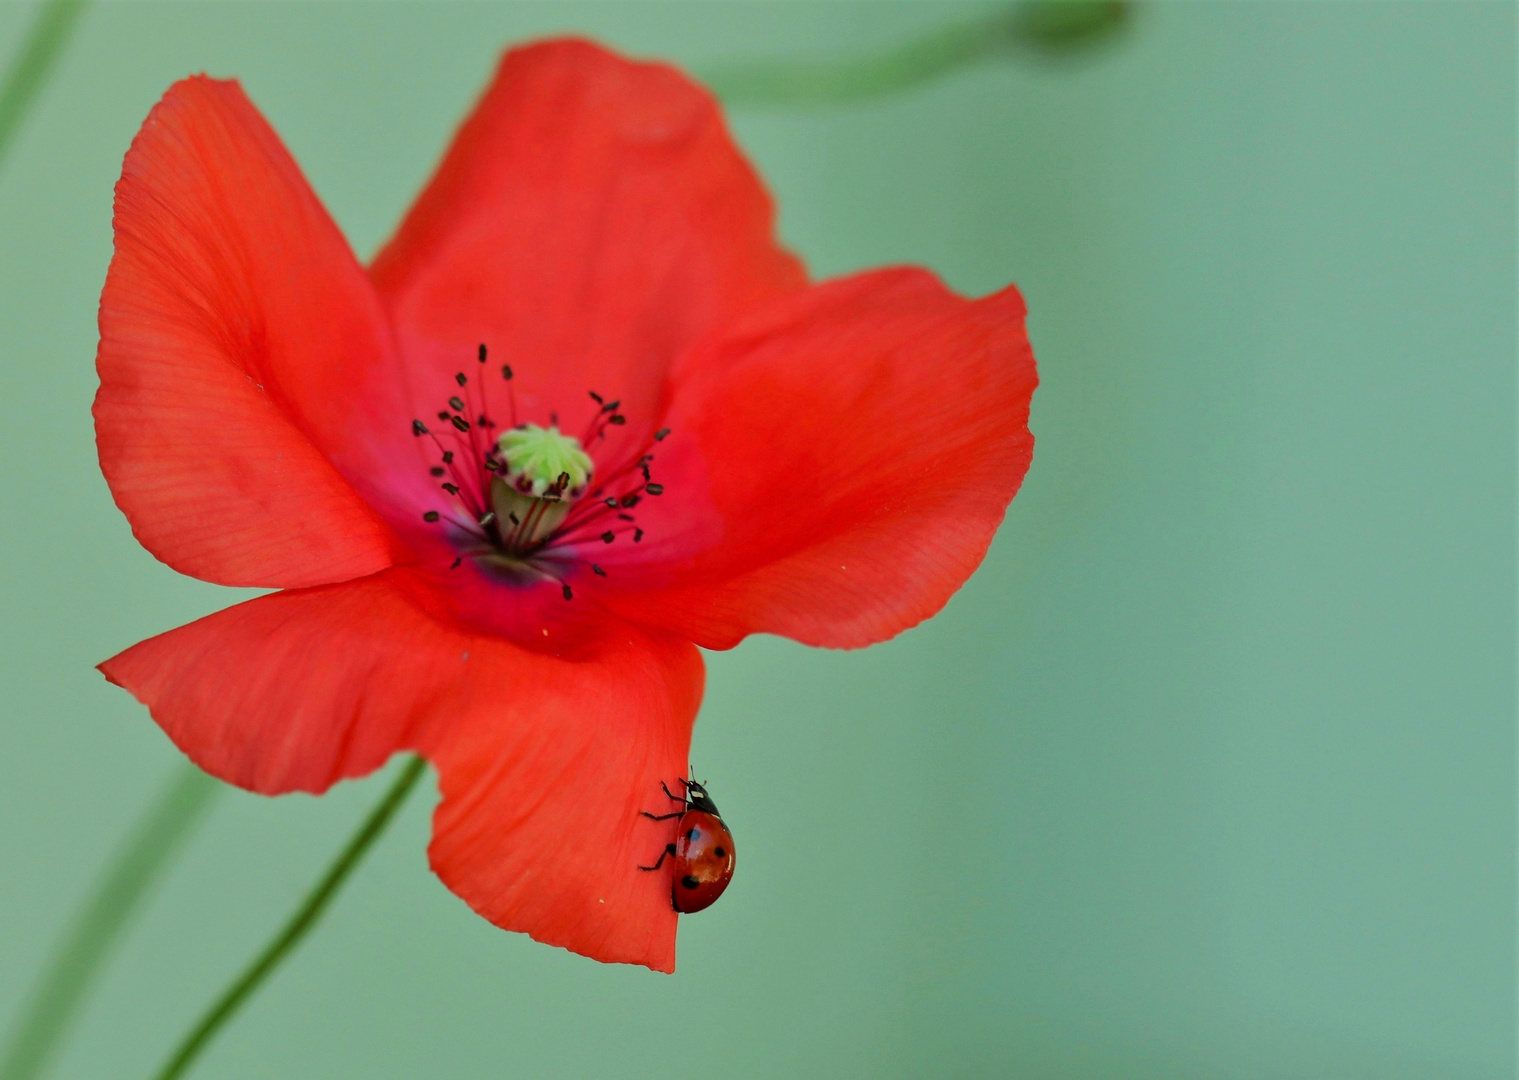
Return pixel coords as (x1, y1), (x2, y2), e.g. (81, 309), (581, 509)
(372, 34), (805, 463)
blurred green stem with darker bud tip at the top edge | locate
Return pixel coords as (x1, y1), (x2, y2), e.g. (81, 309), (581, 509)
(699, 0), (1130, 106)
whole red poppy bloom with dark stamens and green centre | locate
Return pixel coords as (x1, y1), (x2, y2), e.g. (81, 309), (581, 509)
(94, 41), (1034, 971)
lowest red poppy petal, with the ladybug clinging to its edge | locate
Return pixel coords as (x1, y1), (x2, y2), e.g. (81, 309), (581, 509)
(100, 571), (702, 971)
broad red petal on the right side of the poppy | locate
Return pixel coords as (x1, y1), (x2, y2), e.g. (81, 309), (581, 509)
(600, 270), (1037, 649)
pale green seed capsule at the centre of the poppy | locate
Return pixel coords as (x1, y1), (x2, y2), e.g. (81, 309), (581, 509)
(491, 424), (594, 554)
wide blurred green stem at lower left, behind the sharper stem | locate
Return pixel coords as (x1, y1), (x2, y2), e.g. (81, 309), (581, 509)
(0, 763), (222, 1080)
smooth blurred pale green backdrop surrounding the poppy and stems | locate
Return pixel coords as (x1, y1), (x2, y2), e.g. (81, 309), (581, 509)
(0, 2), (1516, 1080)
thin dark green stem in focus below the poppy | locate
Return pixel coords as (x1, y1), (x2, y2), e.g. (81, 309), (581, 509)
(155, 755), (427, 1080)
